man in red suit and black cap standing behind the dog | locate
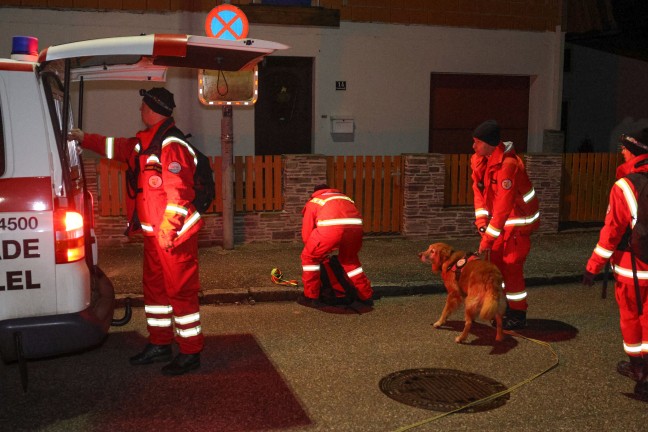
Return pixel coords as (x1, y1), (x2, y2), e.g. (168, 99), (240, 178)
(470, 120), (540, 330)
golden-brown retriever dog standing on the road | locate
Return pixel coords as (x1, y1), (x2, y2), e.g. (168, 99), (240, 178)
(419, 243), (506, 343)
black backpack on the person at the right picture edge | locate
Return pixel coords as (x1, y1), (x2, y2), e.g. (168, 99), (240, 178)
(619, 173), (648, 263)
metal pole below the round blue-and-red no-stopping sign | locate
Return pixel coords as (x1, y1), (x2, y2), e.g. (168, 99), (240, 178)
(221, 105), (234, 250)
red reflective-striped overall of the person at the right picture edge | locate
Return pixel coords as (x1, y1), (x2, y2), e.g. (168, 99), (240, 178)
(586, 154), (648, 357)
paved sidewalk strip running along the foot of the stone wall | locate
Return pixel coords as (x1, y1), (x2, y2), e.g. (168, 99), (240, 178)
(99, 229), (598, 305)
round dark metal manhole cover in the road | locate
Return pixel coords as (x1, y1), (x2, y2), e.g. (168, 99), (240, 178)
(380, 369), (510, 412)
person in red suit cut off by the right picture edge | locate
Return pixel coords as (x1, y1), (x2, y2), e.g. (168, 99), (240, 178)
(583, 129), (648, 401)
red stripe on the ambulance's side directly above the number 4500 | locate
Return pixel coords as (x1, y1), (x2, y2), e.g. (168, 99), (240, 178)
(0, 177), (52, 213)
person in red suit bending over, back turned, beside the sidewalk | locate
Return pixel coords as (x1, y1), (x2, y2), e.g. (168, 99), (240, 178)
(297, 185), (373, 307)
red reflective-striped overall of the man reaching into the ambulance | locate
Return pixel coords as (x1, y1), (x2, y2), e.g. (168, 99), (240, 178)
(82, 121), (204, 354)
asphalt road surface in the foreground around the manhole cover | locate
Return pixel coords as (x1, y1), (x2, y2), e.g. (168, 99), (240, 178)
(0, 284), (648, 432)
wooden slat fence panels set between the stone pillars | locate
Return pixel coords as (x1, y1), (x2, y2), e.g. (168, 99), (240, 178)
(93, 153), (622, 230)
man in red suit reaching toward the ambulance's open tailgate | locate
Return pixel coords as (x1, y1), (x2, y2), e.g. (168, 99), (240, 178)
(70, 87), (204, 375)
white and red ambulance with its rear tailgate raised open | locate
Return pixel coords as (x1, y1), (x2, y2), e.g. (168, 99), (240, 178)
(0, 34), (288, 374)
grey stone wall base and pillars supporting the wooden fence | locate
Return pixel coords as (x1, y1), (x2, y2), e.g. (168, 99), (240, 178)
(85, 153), (562, 246)
